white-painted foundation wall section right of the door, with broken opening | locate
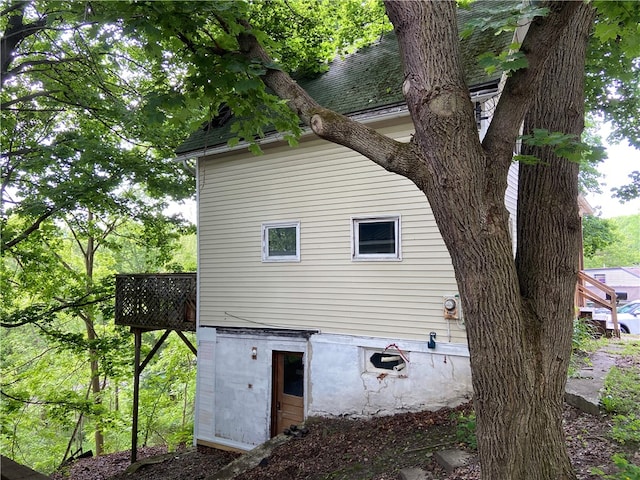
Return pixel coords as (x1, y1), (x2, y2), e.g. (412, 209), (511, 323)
(307, 335), (472, 416)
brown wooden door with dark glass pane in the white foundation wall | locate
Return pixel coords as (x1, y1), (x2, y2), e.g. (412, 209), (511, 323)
(271, 352), (304, 437)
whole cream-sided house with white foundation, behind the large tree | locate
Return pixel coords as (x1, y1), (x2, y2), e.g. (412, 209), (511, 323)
(178, 4), (517, 450)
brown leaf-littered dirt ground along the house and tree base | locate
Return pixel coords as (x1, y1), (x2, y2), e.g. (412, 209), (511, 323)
(53, 405), (640, 480)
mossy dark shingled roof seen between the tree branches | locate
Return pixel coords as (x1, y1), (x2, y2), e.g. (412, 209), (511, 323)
(176, 1), (512, 155)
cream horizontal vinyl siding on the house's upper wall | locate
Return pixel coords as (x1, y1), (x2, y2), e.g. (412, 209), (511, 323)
(198, 121), (466, 342)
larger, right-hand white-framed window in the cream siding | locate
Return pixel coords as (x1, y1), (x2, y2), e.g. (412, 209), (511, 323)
(351, 216), (402, 260)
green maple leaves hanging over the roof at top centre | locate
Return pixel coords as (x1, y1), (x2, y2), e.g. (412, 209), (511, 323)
(79, 0), (391, 153)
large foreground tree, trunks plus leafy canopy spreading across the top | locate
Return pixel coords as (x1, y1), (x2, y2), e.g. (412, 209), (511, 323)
(0, 0), (640, 478)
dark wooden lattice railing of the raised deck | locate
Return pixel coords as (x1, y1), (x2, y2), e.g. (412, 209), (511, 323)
(116, 273), (196, 330)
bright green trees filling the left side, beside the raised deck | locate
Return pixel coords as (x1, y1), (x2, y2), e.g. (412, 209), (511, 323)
(0, 2), (201, 464)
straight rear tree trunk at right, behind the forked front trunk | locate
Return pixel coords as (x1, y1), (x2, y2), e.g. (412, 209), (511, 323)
(490, 4), (594, 479)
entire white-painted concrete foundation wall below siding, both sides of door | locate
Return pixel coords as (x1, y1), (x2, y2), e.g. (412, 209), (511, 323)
(195, 327), (471, 450)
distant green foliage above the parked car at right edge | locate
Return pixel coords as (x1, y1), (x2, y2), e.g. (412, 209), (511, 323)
(585, 214), (640, 268)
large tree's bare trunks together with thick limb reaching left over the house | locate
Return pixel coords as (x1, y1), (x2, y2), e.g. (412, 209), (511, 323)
(240, 0), (592, 480)
